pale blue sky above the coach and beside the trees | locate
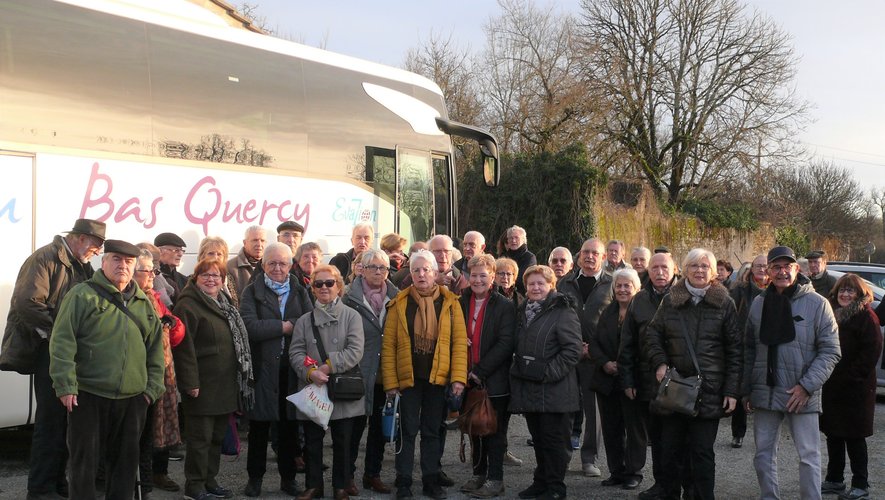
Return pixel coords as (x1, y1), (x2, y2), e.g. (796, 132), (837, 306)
(251, 0), (885, 191)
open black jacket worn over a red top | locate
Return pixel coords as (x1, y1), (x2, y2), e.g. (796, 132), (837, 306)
(460, 288), (516, 397)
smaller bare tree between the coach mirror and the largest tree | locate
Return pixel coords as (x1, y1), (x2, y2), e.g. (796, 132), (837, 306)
(480, 0), (597, 152)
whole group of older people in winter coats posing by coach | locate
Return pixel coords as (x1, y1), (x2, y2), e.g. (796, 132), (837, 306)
(3, 219), (882, 500)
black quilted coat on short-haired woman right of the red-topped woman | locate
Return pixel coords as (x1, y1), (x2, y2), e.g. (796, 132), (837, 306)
(510, 292), (582, 413)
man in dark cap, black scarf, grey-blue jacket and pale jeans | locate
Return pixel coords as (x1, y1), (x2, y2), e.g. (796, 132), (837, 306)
(743, 246), (841, 499)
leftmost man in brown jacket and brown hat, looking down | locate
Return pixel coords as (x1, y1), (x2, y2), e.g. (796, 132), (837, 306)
(0, 219), (105, 499)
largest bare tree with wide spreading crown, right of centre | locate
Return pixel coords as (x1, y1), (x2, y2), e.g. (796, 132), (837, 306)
(579, 0), (807, 205)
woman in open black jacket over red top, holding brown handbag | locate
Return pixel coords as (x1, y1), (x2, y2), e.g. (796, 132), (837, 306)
(461, 254), (516, 498)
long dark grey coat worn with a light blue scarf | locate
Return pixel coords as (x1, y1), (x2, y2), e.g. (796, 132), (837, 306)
(240, 271), (313, 422)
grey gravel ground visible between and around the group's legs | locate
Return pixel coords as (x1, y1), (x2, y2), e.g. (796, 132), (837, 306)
(0, 389), (885, 500)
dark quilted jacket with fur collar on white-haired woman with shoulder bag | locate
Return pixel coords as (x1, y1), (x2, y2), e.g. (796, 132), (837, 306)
(644, 279), (743, 418)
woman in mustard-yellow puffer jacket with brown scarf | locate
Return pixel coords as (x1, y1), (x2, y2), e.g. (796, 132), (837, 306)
(381, 250), (467, 498)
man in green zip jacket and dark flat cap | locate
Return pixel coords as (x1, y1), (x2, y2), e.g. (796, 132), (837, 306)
(49, 240), (165, 499)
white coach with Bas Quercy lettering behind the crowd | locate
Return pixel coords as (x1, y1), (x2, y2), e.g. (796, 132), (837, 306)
(0, 0), (498, 427)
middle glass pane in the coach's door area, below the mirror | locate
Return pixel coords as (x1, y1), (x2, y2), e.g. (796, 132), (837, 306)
(396, 149), (434, 242)
